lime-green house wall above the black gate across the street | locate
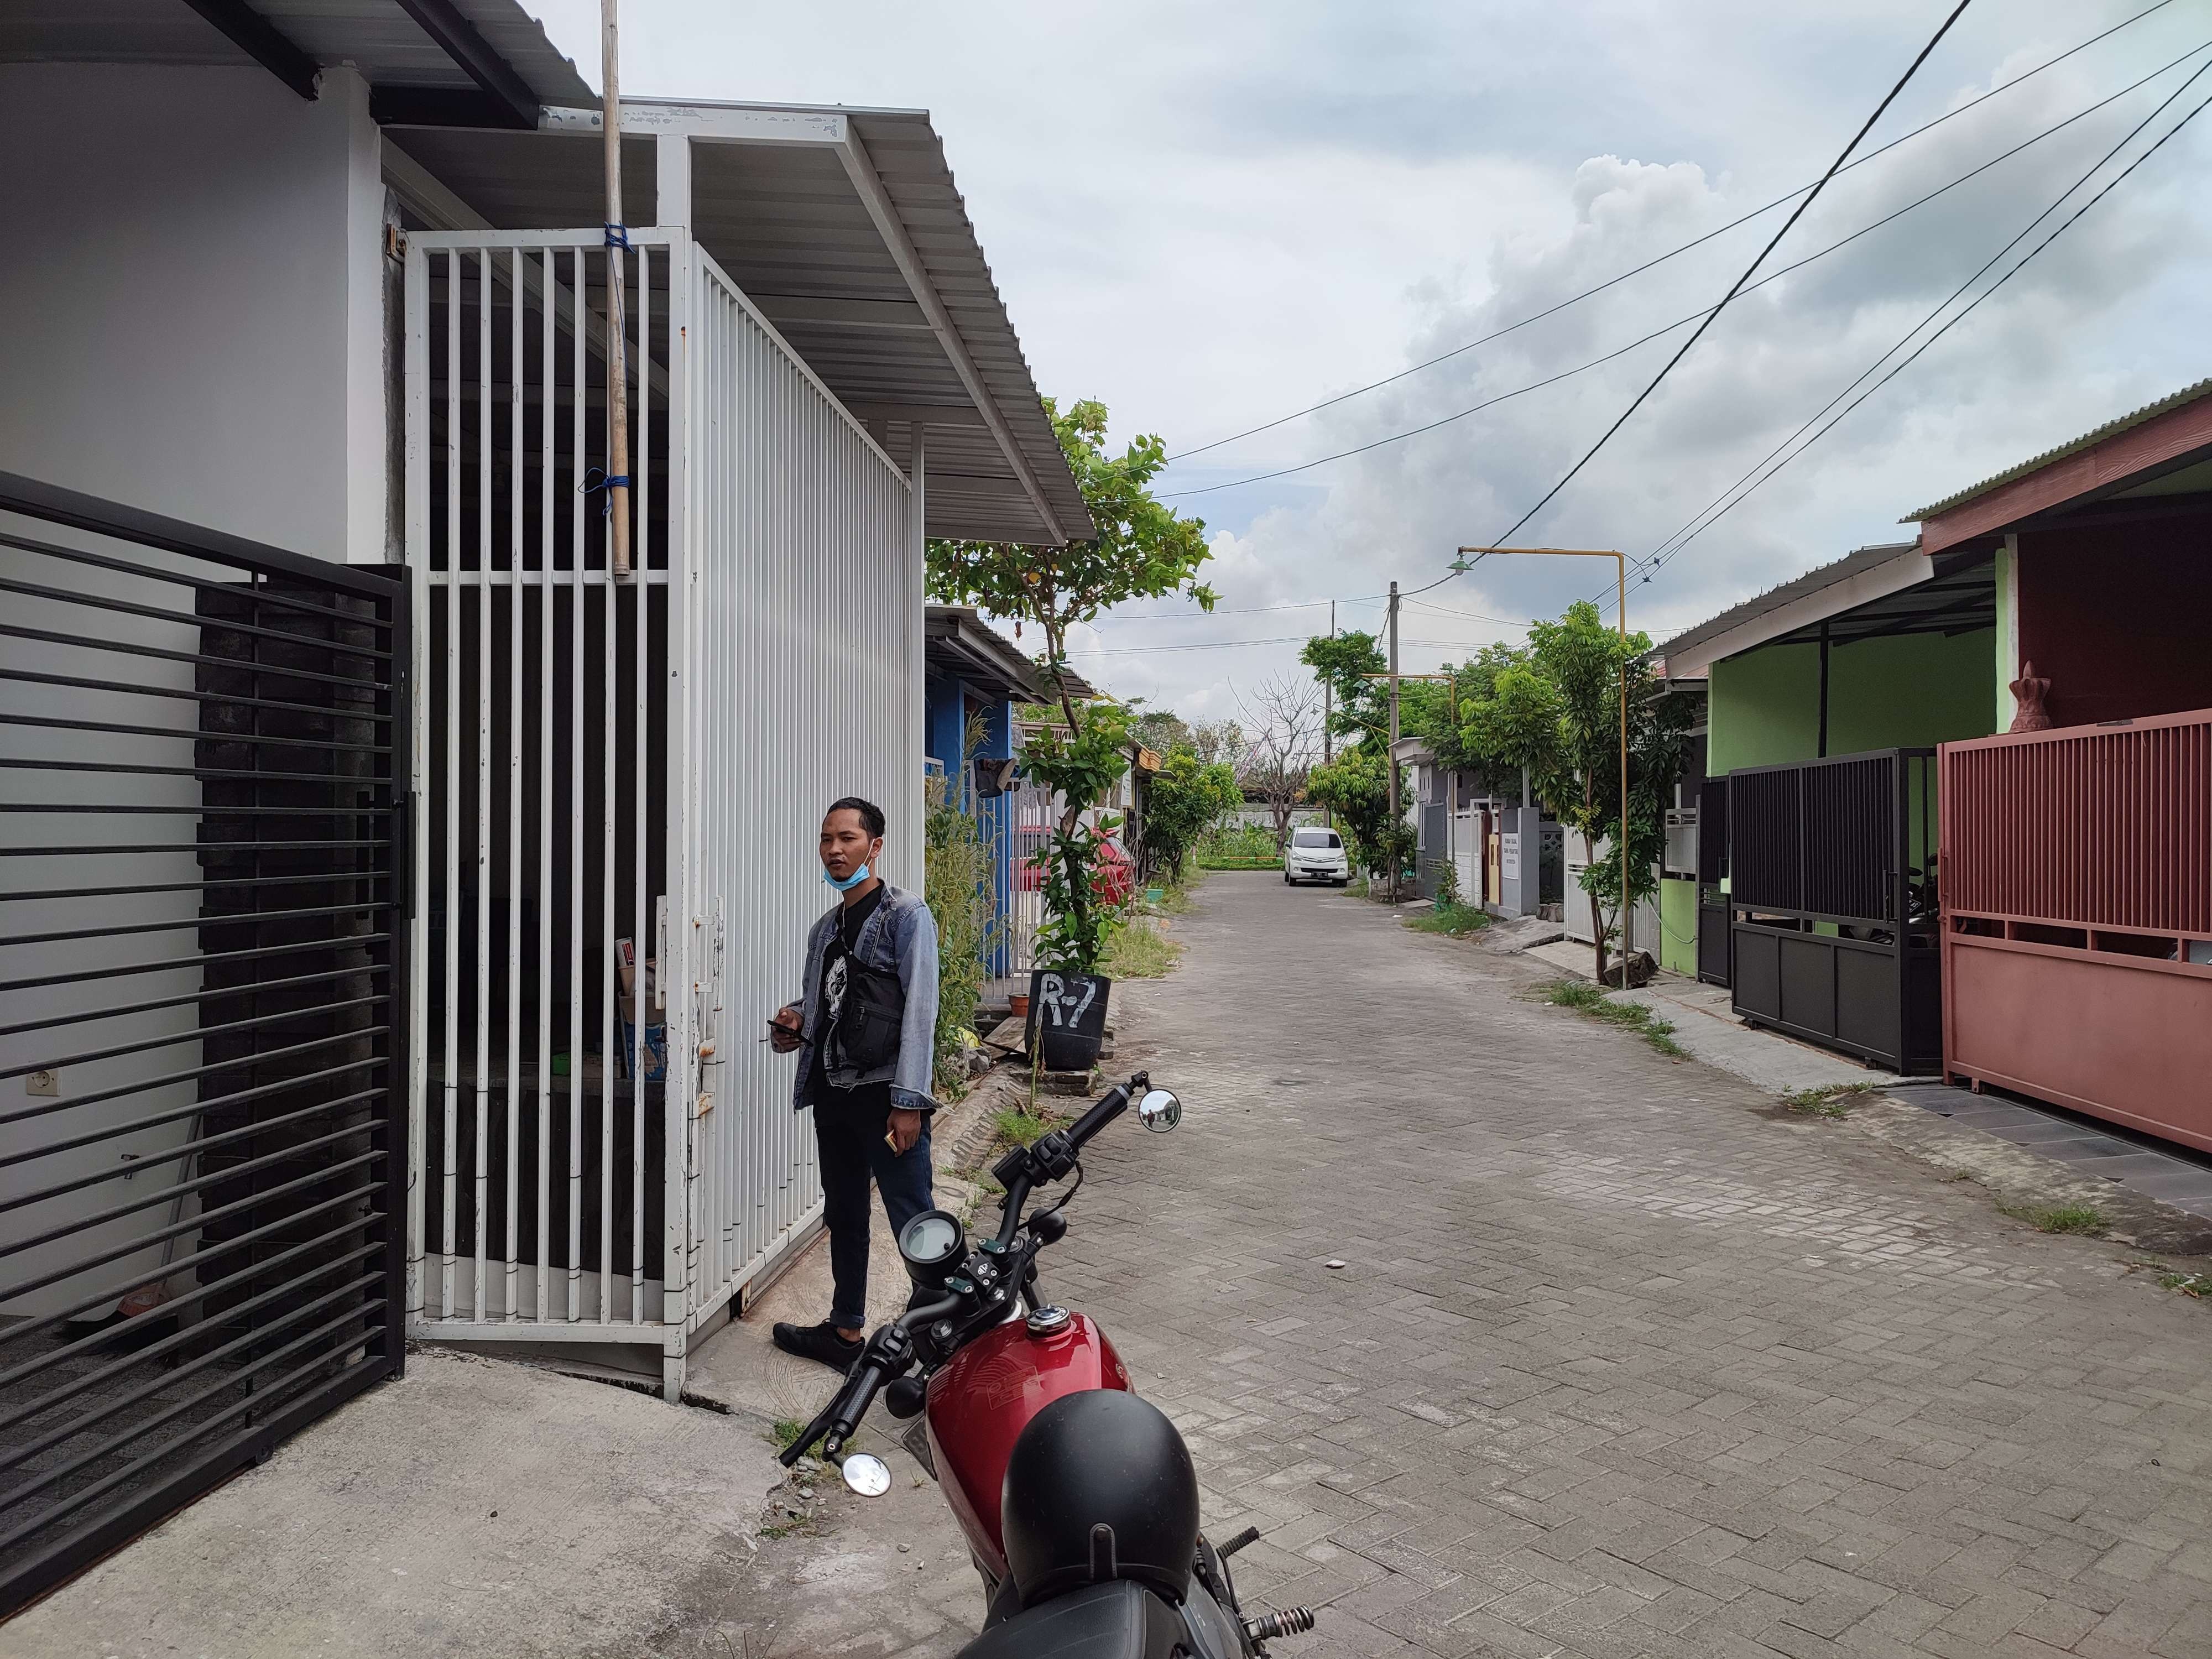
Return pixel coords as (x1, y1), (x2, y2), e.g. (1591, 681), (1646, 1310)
(1708, 628), (1995, 776)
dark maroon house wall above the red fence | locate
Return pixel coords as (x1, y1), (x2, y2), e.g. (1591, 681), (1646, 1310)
(2015, 515), (2212, 726)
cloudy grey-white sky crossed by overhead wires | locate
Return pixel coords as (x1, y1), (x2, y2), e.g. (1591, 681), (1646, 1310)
(531, 0), (2212, 719)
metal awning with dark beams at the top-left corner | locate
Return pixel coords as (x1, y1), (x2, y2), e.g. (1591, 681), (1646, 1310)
(0, 0), (593, 128)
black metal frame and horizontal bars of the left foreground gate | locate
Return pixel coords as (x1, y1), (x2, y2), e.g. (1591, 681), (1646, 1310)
(0, 473), (414, 1617)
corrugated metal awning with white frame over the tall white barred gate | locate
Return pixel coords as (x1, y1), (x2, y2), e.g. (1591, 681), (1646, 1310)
(385, 100), (1093, 546)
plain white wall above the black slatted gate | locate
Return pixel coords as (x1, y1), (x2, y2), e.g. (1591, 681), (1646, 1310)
(0, 64), (387, 562)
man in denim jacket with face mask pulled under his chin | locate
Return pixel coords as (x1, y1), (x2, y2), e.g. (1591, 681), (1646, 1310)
(770, 796), (938, 1371)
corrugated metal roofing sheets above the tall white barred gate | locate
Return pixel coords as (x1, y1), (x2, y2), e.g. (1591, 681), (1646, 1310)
(385, 100), (1093, 542)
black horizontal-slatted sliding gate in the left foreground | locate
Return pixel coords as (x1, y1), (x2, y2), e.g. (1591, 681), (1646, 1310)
(0, 473), (409, 1615)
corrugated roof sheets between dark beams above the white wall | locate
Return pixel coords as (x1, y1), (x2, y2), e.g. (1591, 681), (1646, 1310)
(0, 0), (595, 104)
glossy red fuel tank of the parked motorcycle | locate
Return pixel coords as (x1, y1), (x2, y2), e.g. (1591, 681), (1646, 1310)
(927, 1314), (1128, 1577)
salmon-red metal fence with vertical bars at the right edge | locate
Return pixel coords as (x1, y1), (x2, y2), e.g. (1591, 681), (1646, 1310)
(1938, 710), (2212, 1150)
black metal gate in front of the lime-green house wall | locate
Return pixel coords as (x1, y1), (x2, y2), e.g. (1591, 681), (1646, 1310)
(1728, 750), (1942, 1071)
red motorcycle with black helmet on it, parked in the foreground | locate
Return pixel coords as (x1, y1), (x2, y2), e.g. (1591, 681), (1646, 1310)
(783, 1071), (1314, 1659)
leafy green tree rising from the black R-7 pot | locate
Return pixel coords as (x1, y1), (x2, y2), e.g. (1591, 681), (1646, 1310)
(929, 398), (1214, 973)
